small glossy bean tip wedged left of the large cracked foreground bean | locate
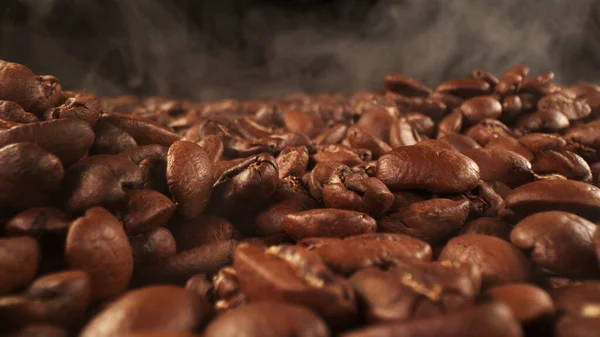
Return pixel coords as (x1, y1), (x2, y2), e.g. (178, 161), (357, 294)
(213, 267), (248, 312)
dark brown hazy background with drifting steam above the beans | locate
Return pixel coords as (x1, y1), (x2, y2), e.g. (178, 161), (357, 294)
(0, 0), (600, 99)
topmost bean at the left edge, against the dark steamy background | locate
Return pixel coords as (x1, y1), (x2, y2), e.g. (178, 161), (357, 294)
(0, 60), (62, 114)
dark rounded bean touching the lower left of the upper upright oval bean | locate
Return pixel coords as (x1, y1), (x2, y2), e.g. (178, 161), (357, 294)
(122, 190), (177, 235)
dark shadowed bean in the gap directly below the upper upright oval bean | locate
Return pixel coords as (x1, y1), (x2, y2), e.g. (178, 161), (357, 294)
(169, 215), (239, 252)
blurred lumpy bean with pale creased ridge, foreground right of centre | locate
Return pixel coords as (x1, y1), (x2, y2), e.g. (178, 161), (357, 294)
(350, 261), (480, 323)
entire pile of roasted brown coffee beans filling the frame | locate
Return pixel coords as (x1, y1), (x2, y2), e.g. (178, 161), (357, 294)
(0, 61), (600, 337)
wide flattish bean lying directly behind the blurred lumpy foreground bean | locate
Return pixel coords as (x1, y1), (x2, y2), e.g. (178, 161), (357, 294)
(298, 233), (431, 275)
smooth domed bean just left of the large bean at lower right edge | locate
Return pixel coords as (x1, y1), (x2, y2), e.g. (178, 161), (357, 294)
(439, 234), (531, 287)
